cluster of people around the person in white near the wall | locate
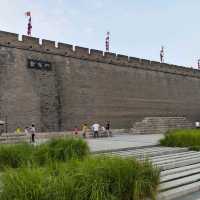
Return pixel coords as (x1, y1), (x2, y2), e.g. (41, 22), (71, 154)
(74, 121), (112, 138)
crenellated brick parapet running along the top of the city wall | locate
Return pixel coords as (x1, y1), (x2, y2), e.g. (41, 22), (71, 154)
(0, 31), (200, 78)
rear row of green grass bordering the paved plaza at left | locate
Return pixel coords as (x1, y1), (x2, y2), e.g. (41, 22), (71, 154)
(0, 137), (89, 169)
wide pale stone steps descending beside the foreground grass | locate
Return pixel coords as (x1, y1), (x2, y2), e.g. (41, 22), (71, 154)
(103, 146), (200, 200)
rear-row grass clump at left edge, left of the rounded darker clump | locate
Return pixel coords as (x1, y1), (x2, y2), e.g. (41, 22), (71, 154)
(0, 143), (33, 169)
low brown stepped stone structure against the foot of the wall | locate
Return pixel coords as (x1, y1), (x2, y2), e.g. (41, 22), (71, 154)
(130, 117), (194, 134)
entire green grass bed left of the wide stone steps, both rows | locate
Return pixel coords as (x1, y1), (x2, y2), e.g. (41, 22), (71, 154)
(0, 138), (159, 200)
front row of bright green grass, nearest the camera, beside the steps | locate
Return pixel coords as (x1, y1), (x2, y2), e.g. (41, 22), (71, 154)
(0, 156), (159, 200)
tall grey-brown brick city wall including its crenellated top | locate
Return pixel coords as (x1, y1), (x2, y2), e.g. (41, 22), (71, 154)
(0, 32), (200, 131)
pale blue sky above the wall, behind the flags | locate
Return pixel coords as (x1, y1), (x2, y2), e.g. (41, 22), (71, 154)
(0, 0), (200, 68)
